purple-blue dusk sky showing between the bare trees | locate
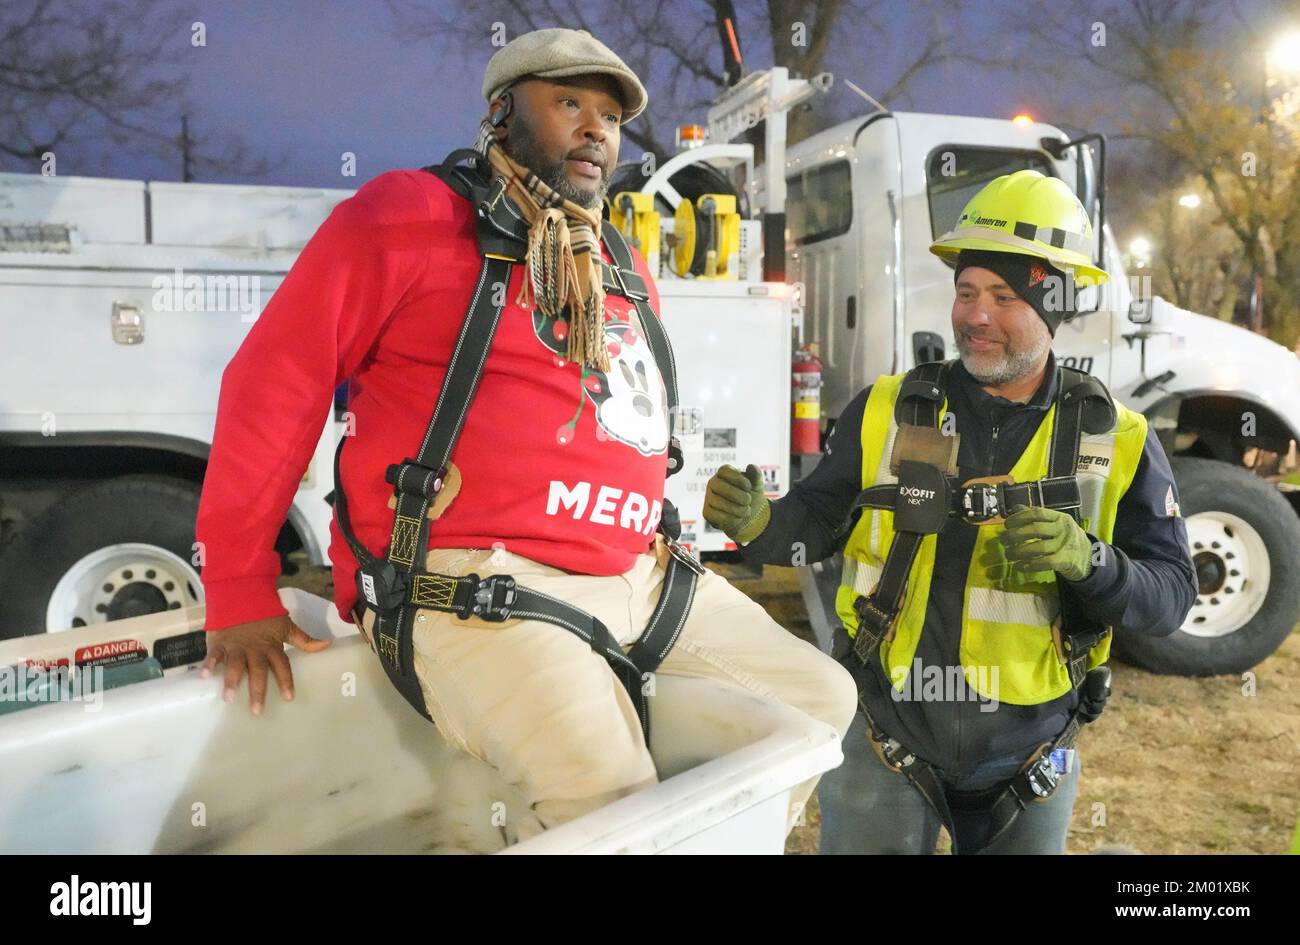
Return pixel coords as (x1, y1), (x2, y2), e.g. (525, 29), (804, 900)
(12, 0), (1284, 201)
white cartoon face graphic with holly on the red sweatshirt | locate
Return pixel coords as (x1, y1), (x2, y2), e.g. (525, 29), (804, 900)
(533, 298), (668, 456)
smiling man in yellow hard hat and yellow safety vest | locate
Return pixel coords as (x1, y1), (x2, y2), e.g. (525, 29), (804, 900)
(705, 170), (1196, 853)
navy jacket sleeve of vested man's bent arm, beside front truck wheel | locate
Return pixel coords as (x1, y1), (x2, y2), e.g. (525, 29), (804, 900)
(1061, 429), (1196, 637)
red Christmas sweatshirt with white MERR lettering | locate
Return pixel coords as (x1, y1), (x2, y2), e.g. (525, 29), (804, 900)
(196, 170), (668, 630)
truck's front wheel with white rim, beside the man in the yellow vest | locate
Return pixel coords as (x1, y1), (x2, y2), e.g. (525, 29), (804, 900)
(1115, 456), (1300, 676)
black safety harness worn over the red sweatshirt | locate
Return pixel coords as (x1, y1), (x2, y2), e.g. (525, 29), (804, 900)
(334, 148), (703, 742)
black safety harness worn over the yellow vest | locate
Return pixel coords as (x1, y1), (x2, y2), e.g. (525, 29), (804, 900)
(848, 361), (1115, 853)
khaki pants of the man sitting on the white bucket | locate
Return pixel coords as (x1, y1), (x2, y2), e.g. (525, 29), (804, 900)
(361, 538), (857, 842)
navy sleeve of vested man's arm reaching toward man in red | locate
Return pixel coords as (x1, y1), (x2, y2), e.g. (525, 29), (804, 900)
(740, 387), (871, 567)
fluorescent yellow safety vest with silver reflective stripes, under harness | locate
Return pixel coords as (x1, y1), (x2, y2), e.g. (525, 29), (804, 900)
(836, 374), (1147, 706)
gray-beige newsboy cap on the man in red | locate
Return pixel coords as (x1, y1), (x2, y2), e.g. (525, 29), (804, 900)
(484, 29), (649, 125)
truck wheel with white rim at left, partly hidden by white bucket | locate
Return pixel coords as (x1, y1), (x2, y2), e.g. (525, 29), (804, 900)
(0, 476), (203, 640)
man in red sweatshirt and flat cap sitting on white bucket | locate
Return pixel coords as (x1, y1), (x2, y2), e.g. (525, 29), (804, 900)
(196, 30), (857, 841)
